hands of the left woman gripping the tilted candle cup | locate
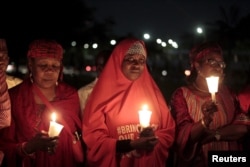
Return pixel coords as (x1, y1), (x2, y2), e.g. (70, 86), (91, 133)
(23, 131), (58, 154)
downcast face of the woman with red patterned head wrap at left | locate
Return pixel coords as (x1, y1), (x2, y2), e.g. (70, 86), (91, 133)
(29, 58), (61, 88)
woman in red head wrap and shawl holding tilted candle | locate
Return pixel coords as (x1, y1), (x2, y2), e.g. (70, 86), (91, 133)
(1, 40), (84, 167)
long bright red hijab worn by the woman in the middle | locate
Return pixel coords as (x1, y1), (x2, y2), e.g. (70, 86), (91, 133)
(83, 39), (175, 167)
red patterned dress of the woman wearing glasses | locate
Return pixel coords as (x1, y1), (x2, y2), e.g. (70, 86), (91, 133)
(171, 86), (241, 167)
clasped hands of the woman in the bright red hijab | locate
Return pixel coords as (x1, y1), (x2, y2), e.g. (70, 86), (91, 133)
(131, 127), (158, 151)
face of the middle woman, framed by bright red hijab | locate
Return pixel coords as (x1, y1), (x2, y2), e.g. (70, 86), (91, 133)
(122, 54), (146, 81)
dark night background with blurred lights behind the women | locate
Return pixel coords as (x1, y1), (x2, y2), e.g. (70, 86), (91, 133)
(0, 0), (250, 100)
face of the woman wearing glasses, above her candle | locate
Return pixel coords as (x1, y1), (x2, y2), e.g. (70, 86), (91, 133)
(197, 53), (226, 77)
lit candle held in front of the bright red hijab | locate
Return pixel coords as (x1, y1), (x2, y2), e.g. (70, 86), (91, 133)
(139, 105), (152, 128)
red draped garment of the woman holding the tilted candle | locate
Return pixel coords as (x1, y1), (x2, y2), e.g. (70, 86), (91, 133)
(1, 79), (81, 167)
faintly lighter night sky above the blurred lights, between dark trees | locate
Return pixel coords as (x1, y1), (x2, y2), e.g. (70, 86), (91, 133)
(85, 0), (250, 39)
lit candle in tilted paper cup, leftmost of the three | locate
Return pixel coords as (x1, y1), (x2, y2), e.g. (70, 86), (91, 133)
(48, 112), (63, 137)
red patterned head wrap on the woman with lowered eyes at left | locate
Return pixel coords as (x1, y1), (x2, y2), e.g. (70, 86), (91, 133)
(27, 39), (63, 60)
